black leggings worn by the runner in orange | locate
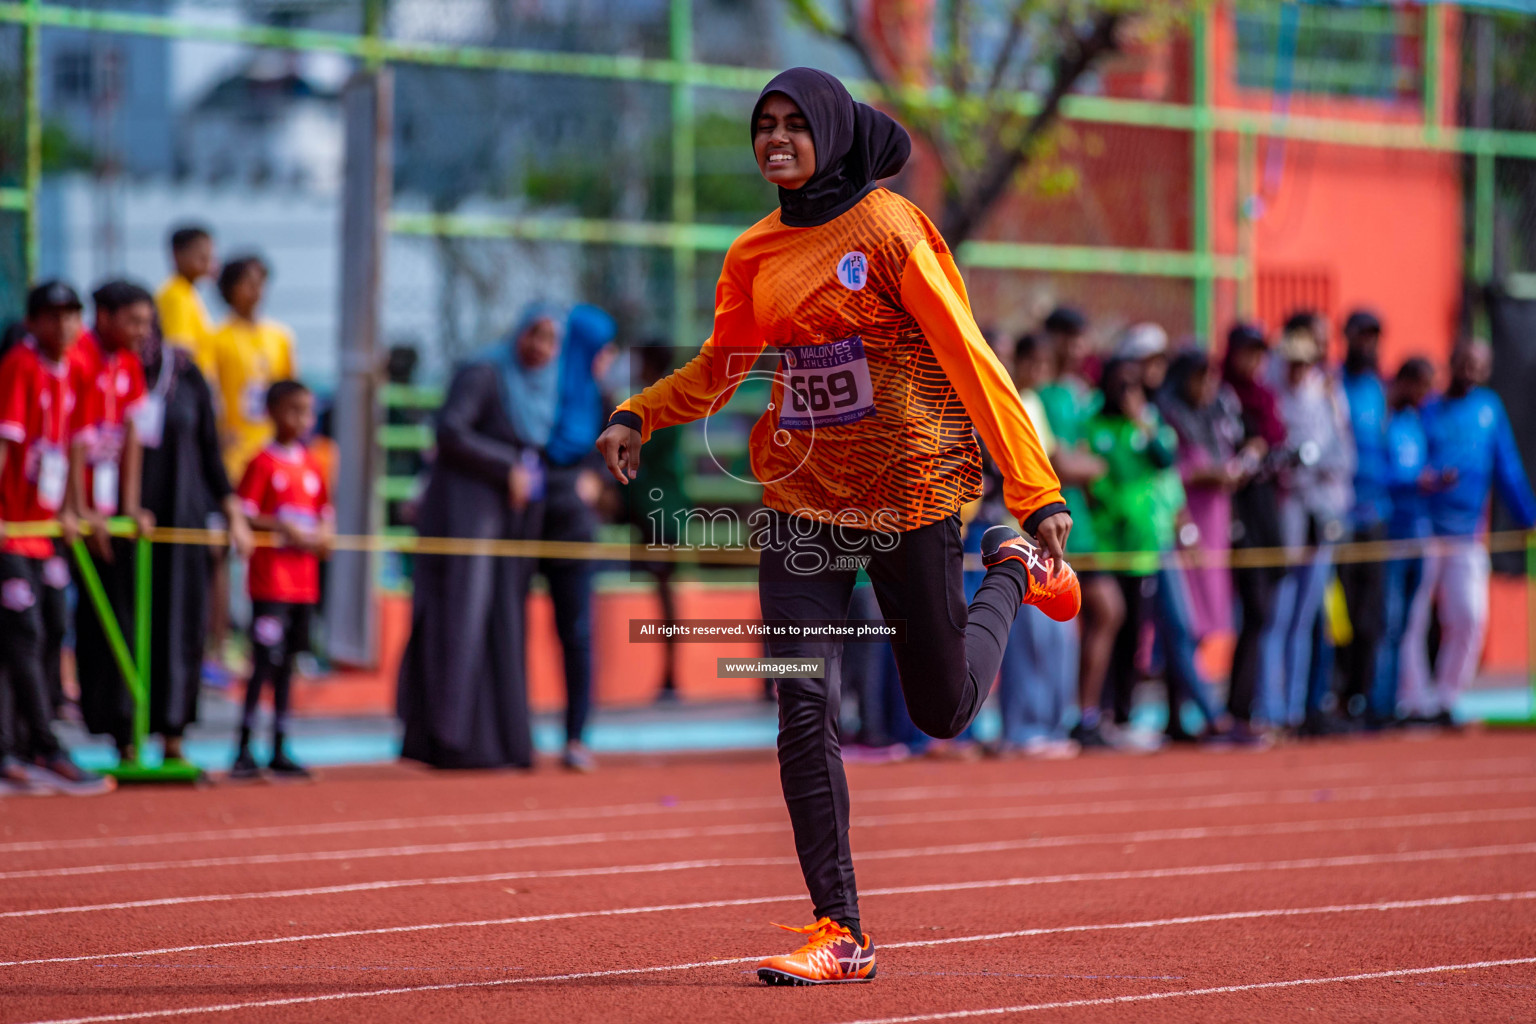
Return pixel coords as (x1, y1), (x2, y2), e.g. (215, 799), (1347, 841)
(757, 510), (1025, 935)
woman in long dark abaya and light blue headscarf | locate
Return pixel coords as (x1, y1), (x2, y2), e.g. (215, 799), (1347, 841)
(398, 306), (564, 768)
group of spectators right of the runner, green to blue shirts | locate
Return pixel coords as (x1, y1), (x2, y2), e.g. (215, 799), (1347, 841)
(845, 309), (1536, 760)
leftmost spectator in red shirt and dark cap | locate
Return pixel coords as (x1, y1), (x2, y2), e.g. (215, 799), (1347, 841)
(0, 281), (112, 794)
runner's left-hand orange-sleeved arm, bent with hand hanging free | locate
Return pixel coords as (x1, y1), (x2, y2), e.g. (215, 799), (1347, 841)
(598, 268), (763, 484)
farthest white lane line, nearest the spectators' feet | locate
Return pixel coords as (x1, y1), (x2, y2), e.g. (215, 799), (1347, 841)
(0, 757), (1536, 854)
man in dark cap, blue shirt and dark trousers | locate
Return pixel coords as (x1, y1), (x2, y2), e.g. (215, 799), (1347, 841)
(1338, 310), (1392, 718)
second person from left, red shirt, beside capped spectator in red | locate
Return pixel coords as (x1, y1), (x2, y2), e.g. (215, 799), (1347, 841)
(68, 281), (164, 761)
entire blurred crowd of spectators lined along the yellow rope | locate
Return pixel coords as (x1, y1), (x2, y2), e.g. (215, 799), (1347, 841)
(0, 226), (1536, 792)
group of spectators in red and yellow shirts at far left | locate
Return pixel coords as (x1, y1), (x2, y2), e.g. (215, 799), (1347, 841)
(0, 226), (333, 794)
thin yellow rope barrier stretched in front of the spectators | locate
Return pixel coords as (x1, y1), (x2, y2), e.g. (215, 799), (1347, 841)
(5, 519), (1536, 571)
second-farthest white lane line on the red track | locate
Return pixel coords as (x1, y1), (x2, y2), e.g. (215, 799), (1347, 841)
(0, 777), (1536, 881)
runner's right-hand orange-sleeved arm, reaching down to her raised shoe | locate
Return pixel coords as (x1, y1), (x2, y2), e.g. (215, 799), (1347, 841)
(902, 241), (1071, 557)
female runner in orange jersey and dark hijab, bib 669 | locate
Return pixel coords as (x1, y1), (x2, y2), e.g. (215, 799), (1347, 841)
(598, 68), (1078, 984)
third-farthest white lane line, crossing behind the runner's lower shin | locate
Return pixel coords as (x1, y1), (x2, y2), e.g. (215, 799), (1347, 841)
(0, 808), (1536, 920)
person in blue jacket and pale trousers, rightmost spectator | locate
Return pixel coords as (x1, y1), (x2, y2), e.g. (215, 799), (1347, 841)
(1399, 339), (1536, 725)
